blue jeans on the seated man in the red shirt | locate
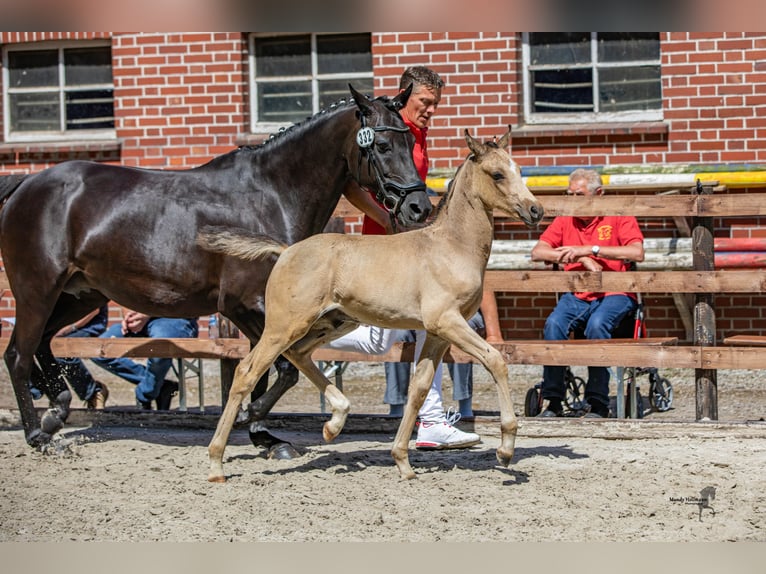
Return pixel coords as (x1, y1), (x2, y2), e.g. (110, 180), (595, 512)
(542, 293), (638, 407)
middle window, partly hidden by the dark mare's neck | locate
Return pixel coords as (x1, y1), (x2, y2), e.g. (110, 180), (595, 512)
(250, 34), (373, 131)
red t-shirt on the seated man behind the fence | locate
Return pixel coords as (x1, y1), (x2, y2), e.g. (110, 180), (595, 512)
(540, 215), (644, 301)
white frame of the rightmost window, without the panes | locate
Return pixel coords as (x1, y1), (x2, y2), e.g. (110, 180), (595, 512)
(521, 32), (663, 125)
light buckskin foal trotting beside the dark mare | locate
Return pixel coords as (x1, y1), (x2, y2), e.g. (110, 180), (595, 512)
(200, 130), (543, 482)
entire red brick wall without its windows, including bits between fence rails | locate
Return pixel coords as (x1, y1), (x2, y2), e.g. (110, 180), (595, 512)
(0, 32), (766, 338)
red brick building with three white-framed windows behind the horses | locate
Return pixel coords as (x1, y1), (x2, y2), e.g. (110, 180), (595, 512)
(0, 32), (766, 339)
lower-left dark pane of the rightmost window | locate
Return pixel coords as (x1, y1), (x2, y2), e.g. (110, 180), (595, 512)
(532, 69), (593, 113)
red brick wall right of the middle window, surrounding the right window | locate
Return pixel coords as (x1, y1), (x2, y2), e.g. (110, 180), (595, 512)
(373, 32), (766, 169)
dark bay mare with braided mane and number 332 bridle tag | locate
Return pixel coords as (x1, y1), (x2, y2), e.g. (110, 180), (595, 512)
(0, 86), (431, 446)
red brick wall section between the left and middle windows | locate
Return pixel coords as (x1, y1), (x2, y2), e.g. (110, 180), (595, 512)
(112, 32), (247, 169)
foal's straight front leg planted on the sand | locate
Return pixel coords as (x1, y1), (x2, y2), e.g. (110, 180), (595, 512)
(391, 333), (449, 479)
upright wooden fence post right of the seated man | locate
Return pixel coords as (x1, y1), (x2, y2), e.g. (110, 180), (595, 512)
(692, 180), (718, 420)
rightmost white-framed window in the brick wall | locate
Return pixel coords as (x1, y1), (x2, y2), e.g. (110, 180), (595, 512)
(522, 32), (662, 124)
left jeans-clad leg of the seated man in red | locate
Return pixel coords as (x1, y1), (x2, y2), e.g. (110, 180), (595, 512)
(539, 293), (590, 417)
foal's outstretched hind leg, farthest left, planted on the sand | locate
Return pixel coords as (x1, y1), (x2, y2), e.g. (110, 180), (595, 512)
(207, 342), (283, 482)
